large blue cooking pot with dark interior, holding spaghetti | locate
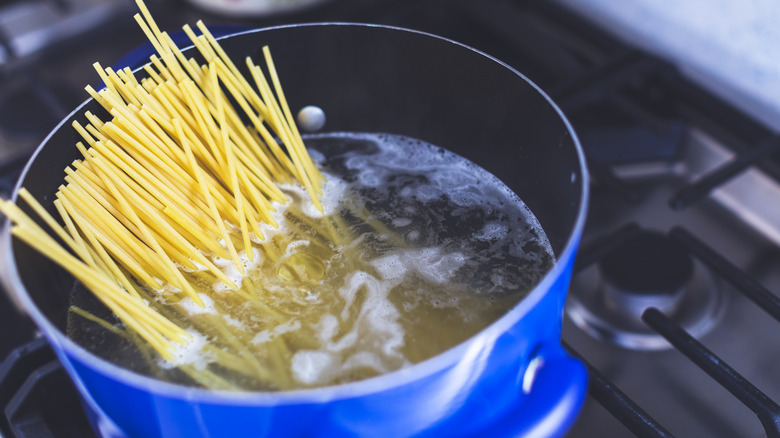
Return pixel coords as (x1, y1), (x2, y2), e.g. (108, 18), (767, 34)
(2, 24), (588, 438)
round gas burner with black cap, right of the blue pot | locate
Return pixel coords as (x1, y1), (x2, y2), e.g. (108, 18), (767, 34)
(567, 230), (724, 350)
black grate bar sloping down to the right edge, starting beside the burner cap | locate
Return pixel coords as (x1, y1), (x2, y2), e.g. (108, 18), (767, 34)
(669, 227), (780, 322)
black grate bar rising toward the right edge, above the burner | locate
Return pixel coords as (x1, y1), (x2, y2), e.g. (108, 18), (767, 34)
(669, 135), (780, 211)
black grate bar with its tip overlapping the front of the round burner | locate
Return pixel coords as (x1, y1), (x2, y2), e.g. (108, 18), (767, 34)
(642, 307), (780, 438)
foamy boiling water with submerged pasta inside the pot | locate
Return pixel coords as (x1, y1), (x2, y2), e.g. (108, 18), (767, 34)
(69, 134), (553, 390)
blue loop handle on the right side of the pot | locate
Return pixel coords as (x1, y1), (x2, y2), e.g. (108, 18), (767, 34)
(484, 345), (588, 438)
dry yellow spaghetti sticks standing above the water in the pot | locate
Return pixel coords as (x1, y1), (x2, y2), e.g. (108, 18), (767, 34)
(0, 0), (324, 370)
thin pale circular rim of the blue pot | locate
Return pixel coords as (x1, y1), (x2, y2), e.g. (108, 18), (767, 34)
(0, 22), (589, 406)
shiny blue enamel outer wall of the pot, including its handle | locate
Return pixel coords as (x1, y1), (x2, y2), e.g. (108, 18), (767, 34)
(47, 240), (587, 438)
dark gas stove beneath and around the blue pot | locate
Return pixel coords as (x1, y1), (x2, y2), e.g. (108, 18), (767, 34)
(0, 0), (780, 437)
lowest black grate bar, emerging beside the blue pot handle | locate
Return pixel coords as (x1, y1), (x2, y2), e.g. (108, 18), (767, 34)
(563, 342), (674, 438)
